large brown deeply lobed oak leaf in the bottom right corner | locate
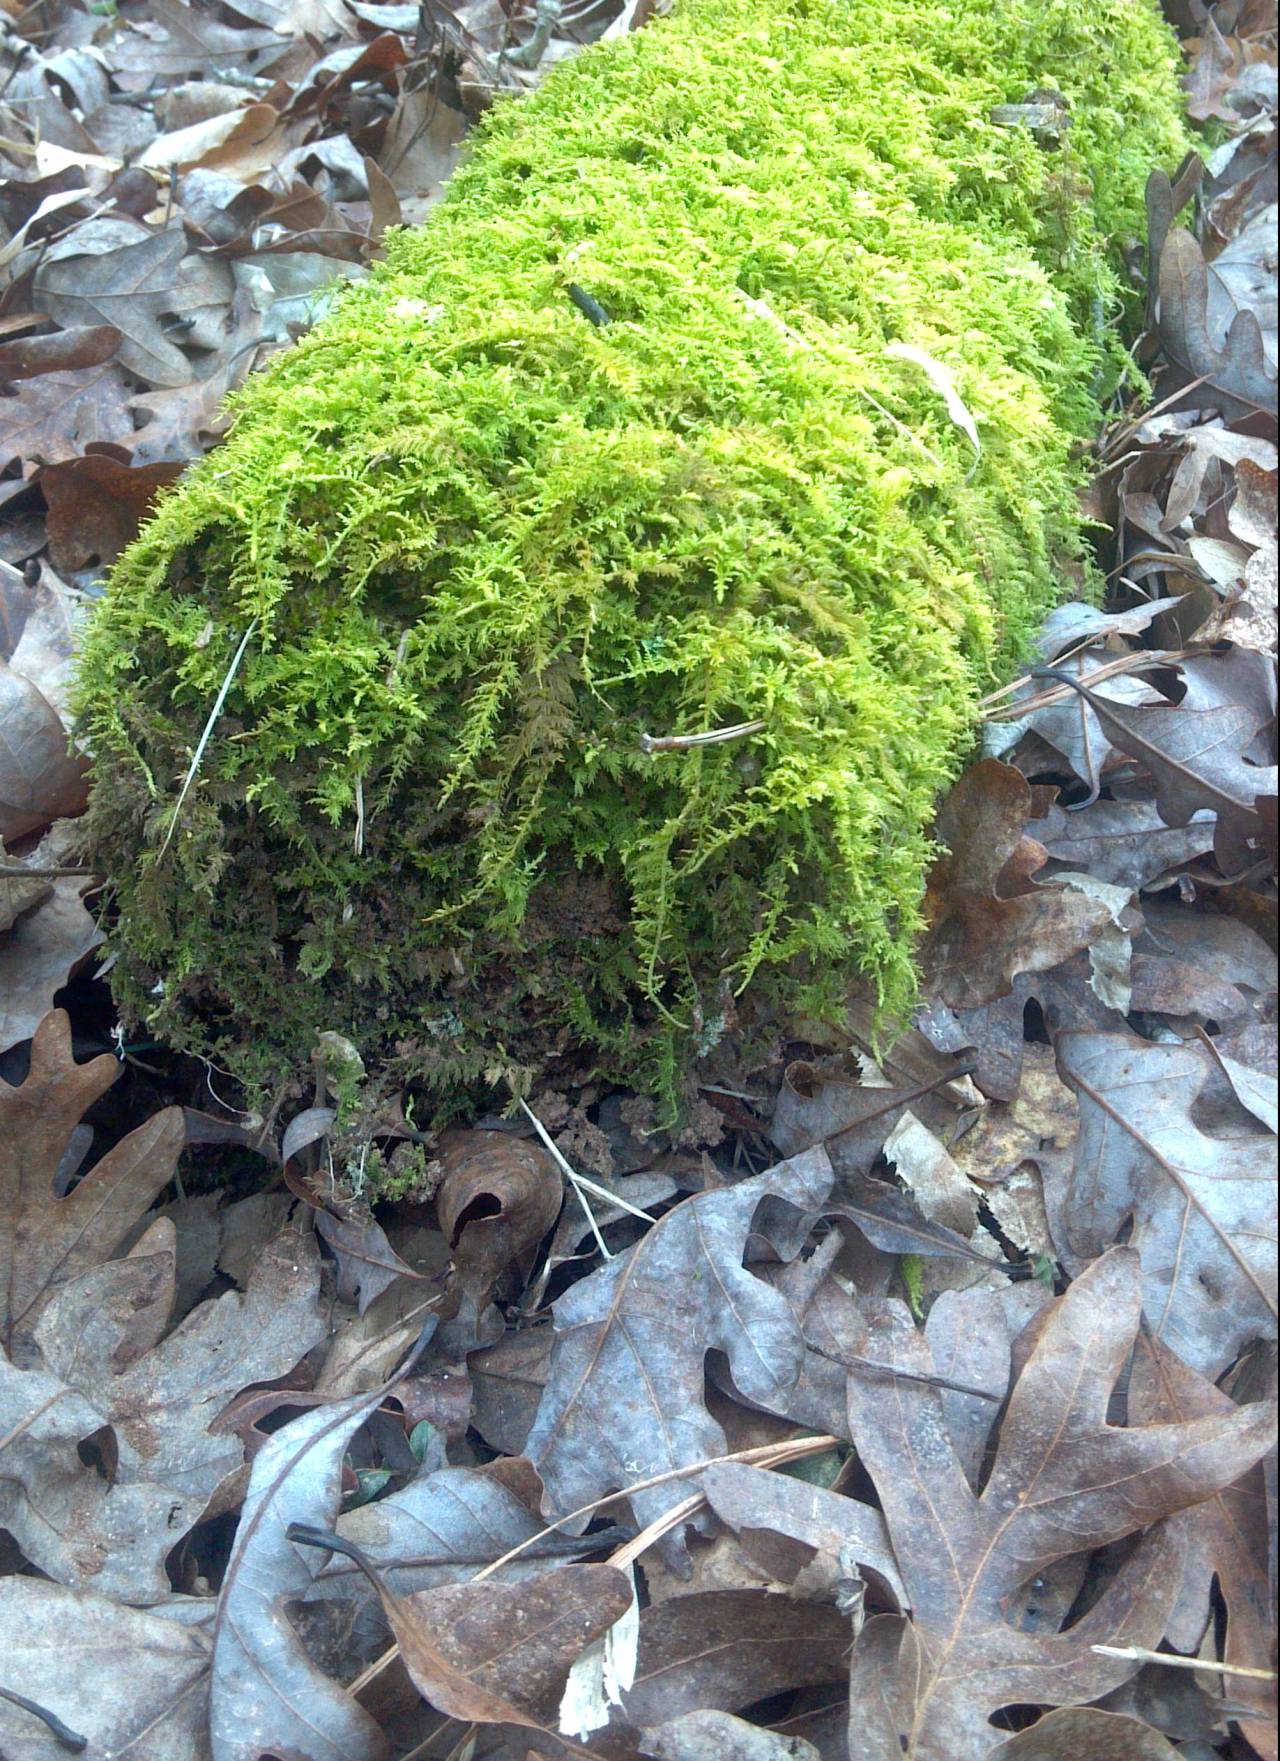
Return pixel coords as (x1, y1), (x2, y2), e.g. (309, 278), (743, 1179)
(849, 1247), (1275, 1761)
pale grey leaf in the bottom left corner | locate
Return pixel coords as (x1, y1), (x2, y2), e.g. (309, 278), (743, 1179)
(0, 1576), (210, 1761)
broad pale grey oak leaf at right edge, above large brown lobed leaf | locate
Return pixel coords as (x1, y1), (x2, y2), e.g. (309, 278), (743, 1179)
(1046, 1034), (1276, 1375)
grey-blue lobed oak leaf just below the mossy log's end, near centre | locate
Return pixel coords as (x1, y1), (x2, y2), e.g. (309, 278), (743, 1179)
(525, 1145), (833, 1567)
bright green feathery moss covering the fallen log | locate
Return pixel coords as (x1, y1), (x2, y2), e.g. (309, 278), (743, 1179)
(79, 0), (1185, 1108)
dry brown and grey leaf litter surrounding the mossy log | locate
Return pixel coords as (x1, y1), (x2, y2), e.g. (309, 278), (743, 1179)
(0, 0), (1276, 1761)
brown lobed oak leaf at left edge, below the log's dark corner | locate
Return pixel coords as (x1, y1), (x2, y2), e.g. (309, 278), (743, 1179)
(0, 1009), (183, 1363)
